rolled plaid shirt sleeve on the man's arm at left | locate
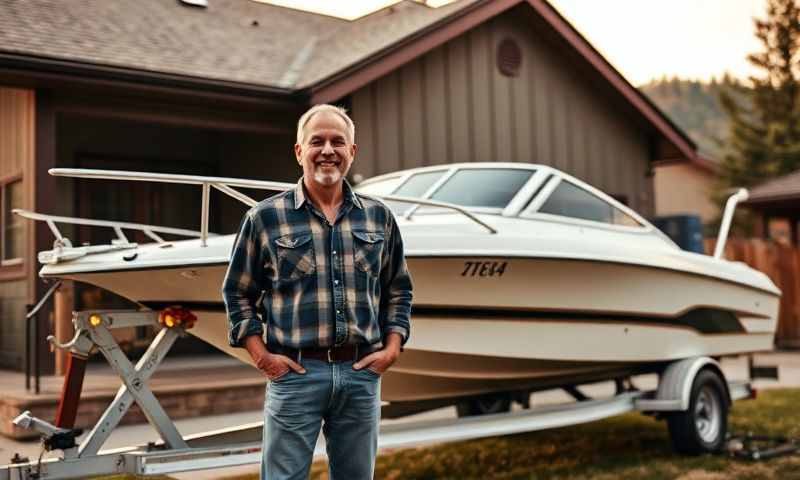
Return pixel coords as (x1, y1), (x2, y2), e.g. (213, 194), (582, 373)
(222, 210), (265, 348)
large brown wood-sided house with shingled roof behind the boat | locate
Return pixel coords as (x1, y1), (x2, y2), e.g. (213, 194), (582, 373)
(0, 0), (696, 368)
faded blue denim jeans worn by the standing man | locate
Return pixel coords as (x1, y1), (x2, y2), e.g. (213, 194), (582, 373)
(261, 360), (381, 480)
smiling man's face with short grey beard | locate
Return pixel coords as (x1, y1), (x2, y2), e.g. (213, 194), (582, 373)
(294, 112), (357, 187)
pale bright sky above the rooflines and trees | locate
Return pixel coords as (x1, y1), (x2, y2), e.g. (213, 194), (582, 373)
(258, 0), (766, 86)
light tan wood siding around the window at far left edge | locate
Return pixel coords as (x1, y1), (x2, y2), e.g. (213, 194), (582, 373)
(0, 87), (35, 368)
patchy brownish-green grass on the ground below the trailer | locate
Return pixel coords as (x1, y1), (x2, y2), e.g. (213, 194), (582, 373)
(311, 389), (800, 480)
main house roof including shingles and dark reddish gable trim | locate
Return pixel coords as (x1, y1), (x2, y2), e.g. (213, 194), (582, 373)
(0, 0), (697, 161)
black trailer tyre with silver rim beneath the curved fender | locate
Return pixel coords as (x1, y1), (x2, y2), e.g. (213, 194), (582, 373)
(667, 370), (728, 455)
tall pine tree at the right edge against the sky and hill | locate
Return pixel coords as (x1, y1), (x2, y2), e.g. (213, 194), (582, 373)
(714, 0), (800, 195)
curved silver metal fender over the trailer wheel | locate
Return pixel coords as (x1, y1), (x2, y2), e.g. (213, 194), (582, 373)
(636, 357), (732, 412)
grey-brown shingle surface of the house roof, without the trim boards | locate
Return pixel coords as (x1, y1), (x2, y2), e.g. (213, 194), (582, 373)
(0, 0), (475, 89)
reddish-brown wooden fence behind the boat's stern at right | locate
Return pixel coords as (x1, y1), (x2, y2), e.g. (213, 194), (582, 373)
(705, 238), (800, 348)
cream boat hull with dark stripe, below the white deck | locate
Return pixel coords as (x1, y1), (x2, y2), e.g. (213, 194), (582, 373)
(58, 255), (779, 402)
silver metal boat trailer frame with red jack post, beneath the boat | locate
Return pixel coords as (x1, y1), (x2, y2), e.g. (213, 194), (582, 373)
(0, 308), (768, 480)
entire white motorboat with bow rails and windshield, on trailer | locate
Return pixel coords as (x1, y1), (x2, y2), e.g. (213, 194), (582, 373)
(20, 163), (781, 414)
